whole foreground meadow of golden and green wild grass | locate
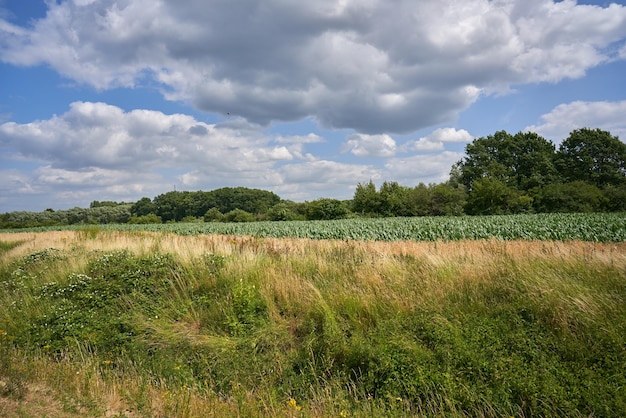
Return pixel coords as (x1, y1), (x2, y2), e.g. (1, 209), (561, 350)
(0, 229), (626, 417)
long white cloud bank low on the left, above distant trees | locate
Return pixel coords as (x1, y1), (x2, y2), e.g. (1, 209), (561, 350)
(0, 102), (410, 210)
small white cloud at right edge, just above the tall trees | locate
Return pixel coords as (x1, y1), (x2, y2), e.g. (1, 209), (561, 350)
(524, 100), (626, 143)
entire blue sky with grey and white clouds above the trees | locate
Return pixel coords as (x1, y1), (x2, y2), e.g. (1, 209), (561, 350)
(0, 0), (626, 212)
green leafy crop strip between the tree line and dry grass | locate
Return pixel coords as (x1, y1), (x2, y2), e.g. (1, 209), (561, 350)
(7, 213), (626, 242)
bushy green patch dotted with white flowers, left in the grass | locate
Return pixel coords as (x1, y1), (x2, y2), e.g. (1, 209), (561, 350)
(17, 251), (178, 354)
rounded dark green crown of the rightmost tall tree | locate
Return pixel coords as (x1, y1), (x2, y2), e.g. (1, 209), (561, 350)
(557, 128), (626, 188)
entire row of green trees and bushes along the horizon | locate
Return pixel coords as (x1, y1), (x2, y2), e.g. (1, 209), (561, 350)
(0, 128), (626, 228)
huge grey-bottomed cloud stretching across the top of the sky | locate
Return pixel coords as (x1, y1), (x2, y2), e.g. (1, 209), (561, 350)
(0, 0), (626, 134)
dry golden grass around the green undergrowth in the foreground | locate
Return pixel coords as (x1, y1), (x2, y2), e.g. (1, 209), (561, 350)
(0, 231), (626, 417)
